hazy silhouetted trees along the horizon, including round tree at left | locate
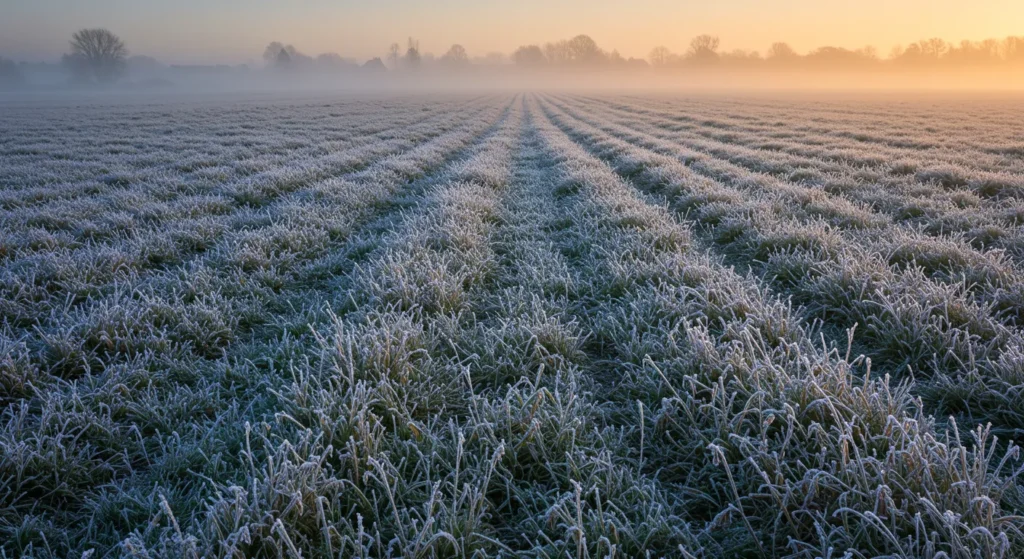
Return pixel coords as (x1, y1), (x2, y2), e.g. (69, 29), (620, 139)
(6, 29), (1024, 86)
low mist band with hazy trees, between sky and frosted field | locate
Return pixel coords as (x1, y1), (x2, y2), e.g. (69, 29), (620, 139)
(0, 23), (1024, 94)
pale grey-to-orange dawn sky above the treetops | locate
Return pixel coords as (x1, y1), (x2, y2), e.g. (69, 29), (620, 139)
(0, 0), (1024, 63)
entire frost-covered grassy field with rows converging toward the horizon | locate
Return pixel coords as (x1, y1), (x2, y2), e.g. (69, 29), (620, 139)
(0, 93), (1024, 559)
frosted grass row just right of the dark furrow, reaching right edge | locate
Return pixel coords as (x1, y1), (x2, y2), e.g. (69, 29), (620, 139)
(536, 94), (1024, 436)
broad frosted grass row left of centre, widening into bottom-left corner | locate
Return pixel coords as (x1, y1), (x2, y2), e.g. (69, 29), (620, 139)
(0, 93), (508, 555)
